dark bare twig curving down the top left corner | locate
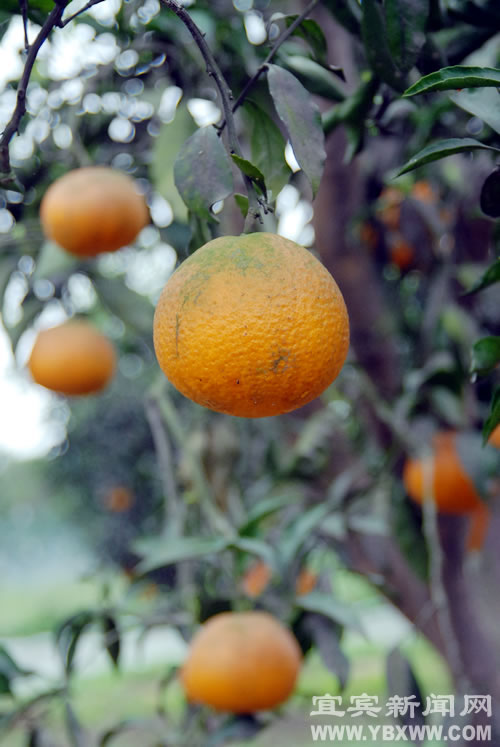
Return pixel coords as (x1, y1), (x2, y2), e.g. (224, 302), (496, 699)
(0, 4), (65, 174)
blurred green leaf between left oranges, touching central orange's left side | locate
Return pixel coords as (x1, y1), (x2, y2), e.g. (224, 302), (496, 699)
(92, 274), (154, 337)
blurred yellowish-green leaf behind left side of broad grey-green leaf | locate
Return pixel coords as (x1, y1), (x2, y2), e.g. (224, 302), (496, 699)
(151, 102), (196, 222)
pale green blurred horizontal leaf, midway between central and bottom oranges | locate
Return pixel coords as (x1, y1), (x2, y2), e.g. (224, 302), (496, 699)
(133, 537), (229, 574)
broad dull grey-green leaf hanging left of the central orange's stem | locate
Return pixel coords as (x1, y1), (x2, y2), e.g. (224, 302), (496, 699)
(174, 126), (233, 219)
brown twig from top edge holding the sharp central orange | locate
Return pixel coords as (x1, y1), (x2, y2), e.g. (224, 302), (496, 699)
(161, 0), (262, 232)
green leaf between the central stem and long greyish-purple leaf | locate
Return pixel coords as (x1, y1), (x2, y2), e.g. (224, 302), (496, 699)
(245, 101), (292, 198)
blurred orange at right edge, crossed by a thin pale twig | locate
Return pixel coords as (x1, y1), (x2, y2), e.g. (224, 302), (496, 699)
(403, 431), (483, 514)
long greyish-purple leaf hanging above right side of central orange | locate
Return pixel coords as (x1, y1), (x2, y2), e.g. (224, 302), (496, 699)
(267, 65), (326, 197)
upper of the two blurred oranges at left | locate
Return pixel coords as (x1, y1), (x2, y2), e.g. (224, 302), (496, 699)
(40, 166), (149, 257)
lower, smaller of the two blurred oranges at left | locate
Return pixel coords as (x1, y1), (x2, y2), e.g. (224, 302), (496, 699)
(28, 321), (116, 394)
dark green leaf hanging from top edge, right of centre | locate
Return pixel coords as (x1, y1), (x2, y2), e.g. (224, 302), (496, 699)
(384, 0), (429, 73)
